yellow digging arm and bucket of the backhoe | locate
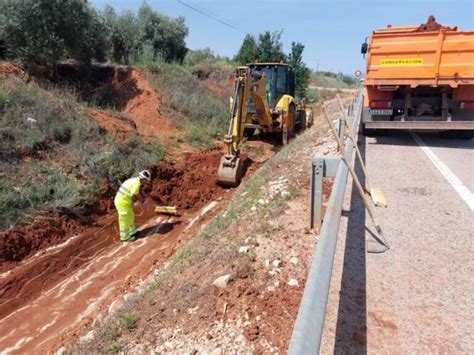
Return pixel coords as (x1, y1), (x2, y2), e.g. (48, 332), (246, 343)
(217, 67), (272, 186)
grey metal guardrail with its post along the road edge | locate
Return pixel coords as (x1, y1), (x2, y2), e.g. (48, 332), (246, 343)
(288, 90), (362, 355)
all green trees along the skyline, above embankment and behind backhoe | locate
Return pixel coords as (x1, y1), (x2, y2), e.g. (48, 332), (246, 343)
(0, 0), (310, 97)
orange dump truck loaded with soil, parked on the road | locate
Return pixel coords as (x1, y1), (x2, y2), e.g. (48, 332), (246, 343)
(361, 16), (474, 135)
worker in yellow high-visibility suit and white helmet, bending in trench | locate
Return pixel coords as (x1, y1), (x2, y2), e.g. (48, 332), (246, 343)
(114, 170), (151, 242)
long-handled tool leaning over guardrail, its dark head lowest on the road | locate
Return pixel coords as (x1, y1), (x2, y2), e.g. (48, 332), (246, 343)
(323, 106), (390, 253)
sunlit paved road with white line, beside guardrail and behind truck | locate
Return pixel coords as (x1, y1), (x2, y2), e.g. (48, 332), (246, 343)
(321, 132), (474, 353)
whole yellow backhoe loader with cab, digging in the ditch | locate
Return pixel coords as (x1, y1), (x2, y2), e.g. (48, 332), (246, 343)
(217, 63), (306, 186)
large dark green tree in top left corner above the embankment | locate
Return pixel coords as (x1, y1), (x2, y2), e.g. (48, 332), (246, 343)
(0, 0), (107, 66)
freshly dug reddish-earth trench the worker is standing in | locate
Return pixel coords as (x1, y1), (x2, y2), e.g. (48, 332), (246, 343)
(0, 150), (253, 353)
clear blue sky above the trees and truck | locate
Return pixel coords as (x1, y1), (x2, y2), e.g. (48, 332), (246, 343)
(89, 0), (474, 74)
